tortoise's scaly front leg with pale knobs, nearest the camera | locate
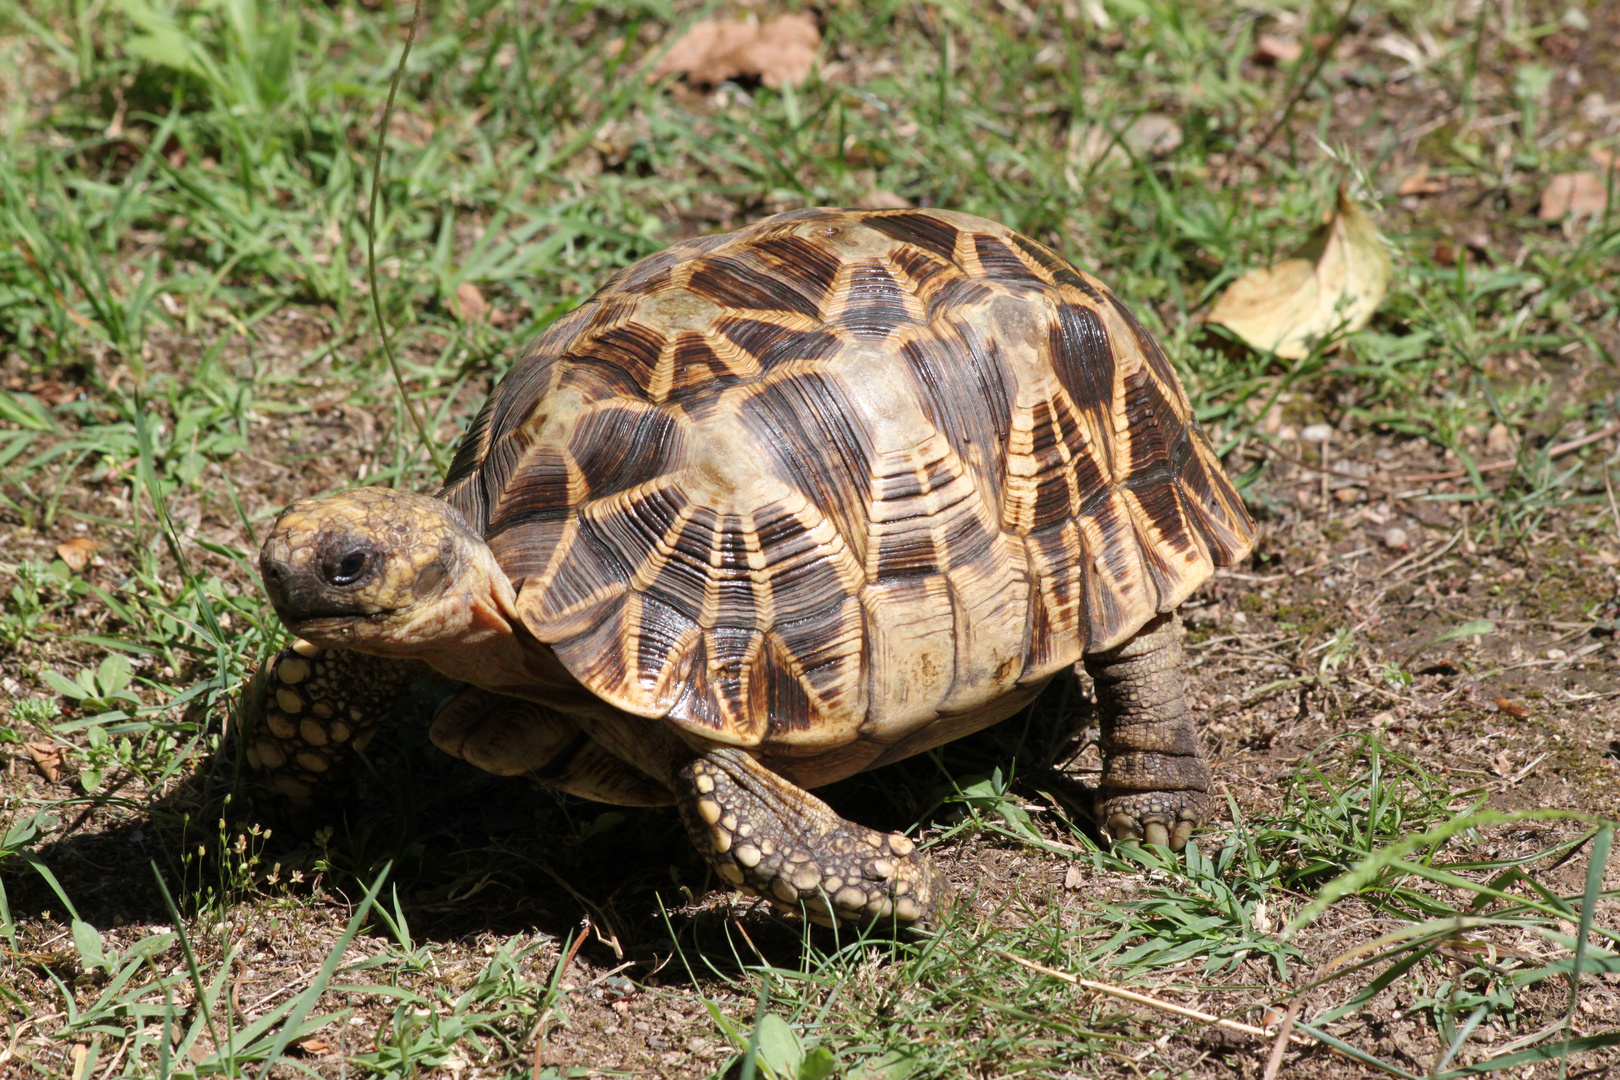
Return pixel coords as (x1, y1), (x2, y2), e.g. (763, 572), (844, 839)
(676, 748), (948, 926)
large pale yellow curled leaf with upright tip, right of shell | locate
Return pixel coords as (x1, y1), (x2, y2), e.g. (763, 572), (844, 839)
(1205, 188), (1393, 359)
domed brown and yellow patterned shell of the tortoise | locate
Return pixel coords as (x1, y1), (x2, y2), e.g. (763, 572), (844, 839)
(441, 209), (1254, 756)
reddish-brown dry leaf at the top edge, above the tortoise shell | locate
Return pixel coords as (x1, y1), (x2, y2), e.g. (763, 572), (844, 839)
(653, 15), (821, 89)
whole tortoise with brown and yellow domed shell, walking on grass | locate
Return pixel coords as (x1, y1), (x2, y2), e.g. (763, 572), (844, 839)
(246, 209), (1254, 925)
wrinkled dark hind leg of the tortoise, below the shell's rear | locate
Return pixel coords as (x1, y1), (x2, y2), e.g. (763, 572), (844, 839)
(1085, 614), (1210, 852)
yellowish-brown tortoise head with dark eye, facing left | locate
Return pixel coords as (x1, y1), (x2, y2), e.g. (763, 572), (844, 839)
(259, 487), (514, 664)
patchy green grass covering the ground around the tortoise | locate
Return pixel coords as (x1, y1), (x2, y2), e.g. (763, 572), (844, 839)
(0, 0), (1620, 1078)
